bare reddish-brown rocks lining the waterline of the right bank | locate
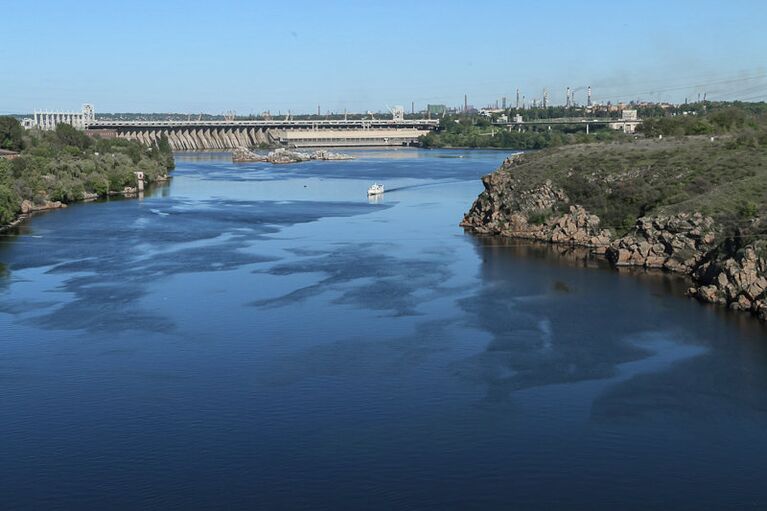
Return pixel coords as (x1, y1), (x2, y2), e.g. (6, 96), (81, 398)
(460, 158), (767, 321)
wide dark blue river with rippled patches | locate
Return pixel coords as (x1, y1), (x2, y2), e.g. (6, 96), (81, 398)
(0, 150), (767, 510)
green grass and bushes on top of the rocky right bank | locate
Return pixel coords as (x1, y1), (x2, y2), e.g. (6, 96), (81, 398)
(498, 104), (767, 236)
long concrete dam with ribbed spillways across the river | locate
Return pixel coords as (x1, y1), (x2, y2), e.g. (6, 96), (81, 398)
(87, 118), (439, 151)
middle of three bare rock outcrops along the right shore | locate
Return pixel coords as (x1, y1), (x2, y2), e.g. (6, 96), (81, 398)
(607, 213), (717, 274)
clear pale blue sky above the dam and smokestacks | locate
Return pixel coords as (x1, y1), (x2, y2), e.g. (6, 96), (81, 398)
(0, 0), (767, 115)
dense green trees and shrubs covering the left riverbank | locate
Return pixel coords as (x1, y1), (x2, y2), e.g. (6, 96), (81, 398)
(0, 117), (174, 225)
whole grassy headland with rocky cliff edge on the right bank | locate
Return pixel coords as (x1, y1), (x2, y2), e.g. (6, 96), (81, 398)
(461, 139), (767, 320)
